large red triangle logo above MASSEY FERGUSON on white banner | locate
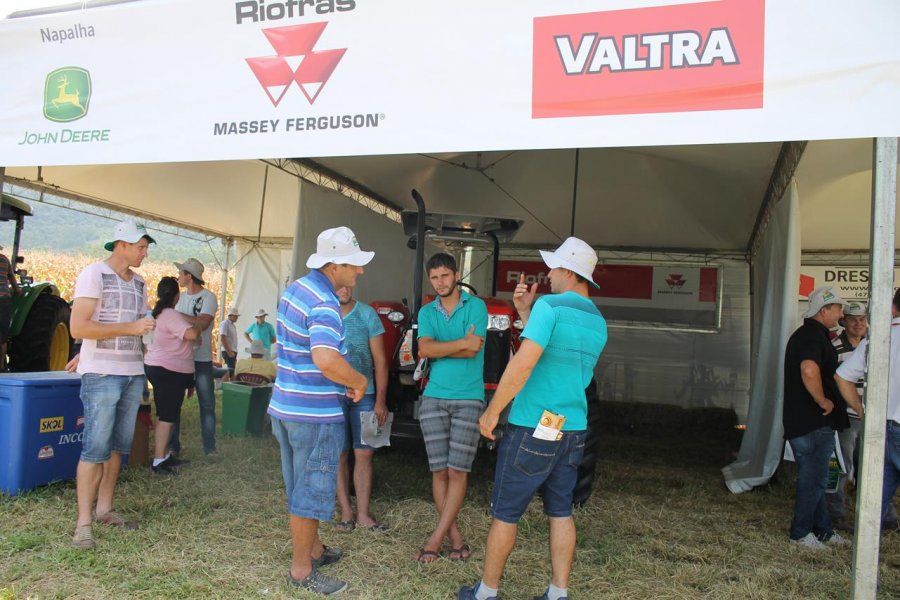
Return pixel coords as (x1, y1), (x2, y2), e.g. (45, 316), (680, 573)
(246, 22), (347, 106)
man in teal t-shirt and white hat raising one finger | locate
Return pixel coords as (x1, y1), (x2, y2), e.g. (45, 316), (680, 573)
(458, 237), (607, 600)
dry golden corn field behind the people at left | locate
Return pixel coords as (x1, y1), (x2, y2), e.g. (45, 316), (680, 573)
(26, 250), (234, 357)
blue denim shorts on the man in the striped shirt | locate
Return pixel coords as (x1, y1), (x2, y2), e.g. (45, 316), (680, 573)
(272, 417), (344, 521)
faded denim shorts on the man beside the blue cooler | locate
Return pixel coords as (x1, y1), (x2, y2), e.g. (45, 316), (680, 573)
(81, 373), (144, 463)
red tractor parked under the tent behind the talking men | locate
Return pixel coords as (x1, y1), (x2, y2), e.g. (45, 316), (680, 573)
(370, 190), (600, 505)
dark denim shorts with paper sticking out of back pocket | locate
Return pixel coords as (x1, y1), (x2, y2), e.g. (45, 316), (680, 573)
(491, 425), (587, 523)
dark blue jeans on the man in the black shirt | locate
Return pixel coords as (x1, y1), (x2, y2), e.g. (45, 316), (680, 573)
(788, 427), (834, 540)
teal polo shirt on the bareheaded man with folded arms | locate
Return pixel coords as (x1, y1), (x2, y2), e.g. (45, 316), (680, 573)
(419, 291), (488, 402)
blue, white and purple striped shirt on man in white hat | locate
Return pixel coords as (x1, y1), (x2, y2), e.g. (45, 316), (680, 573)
(269, 270), (347, 423)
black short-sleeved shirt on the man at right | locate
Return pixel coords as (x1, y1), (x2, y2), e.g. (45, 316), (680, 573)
(782, 319), (850, 439)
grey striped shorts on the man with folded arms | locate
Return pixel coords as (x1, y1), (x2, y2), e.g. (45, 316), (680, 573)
(419, 396), (484, 473)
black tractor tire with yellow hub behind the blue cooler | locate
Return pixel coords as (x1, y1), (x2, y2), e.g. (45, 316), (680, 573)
(9, 294), (74, 373)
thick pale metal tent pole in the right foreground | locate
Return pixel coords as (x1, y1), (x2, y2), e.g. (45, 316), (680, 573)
(851, 138), (897, 600)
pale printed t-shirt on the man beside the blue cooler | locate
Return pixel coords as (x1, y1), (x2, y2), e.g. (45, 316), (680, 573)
(75, 261), (147, 375)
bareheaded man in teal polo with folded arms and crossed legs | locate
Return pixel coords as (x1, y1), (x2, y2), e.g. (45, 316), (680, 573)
(415, 252), (488, 563)
